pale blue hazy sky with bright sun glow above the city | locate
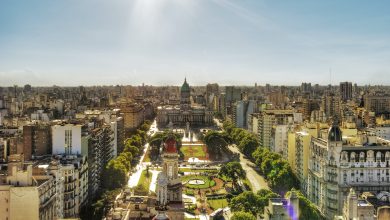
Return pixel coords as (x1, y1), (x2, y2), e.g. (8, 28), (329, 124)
(0, 0), (390, 86)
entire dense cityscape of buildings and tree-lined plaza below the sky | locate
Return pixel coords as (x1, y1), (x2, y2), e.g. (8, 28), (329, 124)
(0, 79), (390, 219)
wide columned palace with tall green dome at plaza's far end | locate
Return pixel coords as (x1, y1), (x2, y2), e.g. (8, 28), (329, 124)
(157, 79), (213, 127)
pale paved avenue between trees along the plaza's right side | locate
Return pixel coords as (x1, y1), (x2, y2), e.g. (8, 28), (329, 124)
(229, 145), (270, 192)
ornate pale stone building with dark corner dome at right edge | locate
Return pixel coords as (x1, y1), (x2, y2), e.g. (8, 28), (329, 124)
(306, 124), (390, 219)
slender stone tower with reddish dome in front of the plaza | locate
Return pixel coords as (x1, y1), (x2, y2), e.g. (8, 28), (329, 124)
(156, 137), (184, 220)
